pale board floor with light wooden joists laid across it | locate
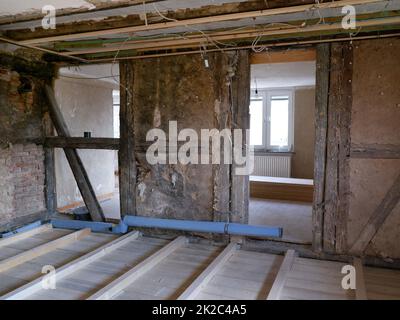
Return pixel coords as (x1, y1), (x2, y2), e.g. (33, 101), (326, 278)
(0, 230), (400, 300)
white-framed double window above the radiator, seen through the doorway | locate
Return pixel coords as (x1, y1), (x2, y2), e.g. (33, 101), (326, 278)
(250, 90), (293, 151)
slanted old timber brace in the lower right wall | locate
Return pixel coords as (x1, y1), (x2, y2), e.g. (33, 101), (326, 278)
(350, 174), (400, 254)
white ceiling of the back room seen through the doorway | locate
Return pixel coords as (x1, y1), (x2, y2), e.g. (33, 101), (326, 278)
(251, 61), (315, 89)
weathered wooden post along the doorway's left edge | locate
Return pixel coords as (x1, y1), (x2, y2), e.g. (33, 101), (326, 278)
(231, 50), (250, 223)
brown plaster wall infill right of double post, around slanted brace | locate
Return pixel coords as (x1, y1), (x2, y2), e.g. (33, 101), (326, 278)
(348, 38), (400, 259)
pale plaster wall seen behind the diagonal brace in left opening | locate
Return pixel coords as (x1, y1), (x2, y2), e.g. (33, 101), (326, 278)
(55, 76), (115, 208)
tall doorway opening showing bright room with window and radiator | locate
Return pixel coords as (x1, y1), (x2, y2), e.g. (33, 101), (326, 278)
(249, 50), (316, 244)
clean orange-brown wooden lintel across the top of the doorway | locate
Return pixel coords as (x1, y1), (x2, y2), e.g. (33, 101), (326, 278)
(250, 48), (317, 64)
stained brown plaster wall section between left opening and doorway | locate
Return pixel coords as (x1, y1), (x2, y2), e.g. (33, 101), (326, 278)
(126, 53), (238, 220)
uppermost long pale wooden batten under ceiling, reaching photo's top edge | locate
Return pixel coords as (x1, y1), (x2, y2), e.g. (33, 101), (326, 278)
(19, 0), (377, 45)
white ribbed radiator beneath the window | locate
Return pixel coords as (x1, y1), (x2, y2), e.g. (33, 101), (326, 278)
(252, 155), (291, 178)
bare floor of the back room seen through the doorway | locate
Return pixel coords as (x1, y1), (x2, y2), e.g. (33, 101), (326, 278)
(249, 198), (312, 243)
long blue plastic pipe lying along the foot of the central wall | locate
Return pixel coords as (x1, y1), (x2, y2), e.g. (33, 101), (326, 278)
(118, 216), (283, 238)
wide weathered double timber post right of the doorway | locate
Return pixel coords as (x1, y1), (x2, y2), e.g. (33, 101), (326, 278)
(313, 43), (353, 253)
